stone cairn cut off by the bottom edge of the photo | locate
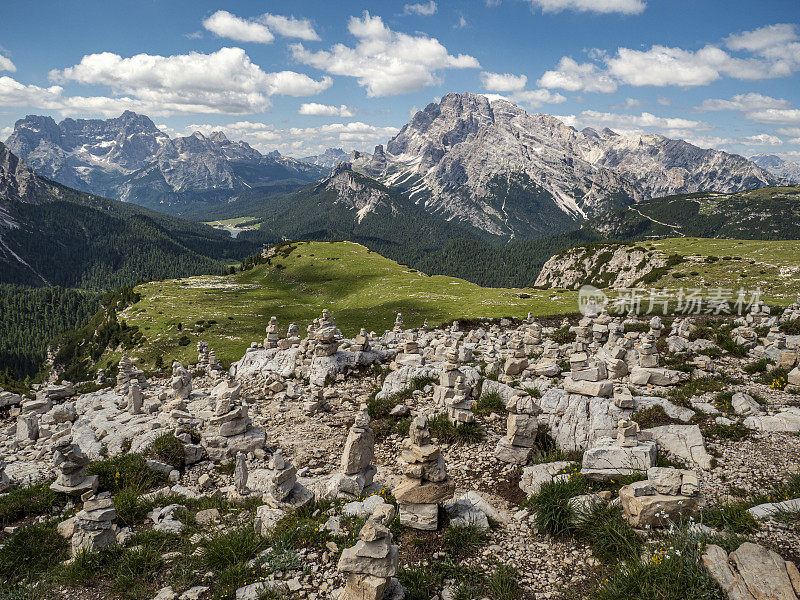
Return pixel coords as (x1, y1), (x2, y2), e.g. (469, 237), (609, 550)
(337, 504), (400, 600)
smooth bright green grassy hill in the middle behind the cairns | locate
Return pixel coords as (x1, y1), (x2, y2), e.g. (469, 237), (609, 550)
(123, 242), (577, 365)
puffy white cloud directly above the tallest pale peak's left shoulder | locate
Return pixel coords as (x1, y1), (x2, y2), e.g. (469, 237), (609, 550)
(291, 12), (480, 97)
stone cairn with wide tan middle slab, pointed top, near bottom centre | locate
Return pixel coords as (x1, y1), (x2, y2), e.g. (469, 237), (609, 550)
(392, 416), (455, 531)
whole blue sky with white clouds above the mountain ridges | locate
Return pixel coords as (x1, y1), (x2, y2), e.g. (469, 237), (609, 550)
(0, 0), (800, 161)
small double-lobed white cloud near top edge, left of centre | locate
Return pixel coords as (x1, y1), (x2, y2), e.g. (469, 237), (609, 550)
(203, 10), (319, 44)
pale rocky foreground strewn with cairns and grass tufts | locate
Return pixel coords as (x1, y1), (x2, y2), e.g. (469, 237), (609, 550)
(0, 307), (800, 600)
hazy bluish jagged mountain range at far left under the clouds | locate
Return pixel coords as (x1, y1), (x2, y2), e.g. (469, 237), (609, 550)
(6, 111), (324, 213)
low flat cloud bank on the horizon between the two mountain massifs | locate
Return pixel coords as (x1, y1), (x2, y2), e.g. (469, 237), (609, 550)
(177, 121), (399, 156)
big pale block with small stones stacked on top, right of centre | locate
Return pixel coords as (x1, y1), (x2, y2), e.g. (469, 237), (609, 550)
(581, 420), (657, 480)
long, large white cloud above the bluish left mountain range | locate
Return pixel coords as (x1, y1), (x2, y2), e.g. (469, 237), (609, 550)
(50, 48), (332, 114)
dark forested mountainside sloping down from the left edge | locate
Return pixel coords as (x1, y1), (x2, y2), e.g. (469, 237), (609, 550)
(0, 144), (257, 289)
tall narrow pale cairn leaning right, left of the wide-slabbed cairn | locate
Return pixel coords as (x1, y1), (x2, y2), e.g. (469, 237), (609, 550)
(330, 404), (377, 499)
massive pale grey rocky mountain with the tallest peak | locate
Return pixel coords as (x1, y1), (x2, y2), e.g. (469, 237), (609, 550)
(351, 93), (777, 239)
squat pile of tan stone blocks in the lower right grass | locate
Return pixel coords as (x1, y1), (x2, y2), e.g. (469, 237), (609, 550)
(619, 467), (702, 527)
